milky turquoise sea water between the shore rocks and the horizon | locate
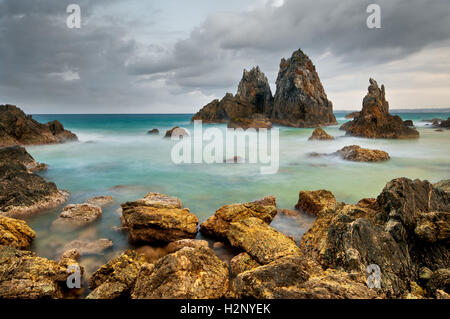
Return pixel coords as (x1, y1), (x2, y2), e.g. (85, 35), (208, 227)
(27, 112), (450, 278)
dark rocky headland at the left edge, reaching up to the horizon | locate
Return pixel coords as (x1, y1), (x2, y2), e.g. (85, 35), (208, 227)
(0, 104), (78, 147)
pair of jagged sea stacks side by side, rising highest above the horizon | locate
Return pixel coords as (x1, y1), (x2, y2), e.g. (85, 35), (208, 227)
(192, 50), (337, 128)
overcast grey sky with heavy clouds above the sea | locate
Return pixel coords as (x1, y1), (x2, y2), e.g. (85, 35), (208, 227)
(0, 0), (450, 113)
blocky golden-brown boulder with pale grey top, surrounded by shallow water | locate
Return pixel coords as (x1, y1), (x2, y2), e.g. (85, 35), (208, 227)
(122, 193), (198, 243)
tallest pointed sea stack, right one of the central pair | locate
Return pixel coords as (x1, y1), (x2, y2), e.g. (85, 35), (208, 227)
(270, 49), (337, 127)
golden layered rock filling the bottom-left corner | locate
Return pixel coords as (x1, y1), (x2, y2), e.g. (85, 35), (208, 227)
(0, 246), (78, 299)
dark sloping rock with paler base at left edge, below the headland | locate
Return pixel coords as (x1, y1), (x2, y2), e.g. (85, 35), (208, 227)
(0, 159), (69, 218)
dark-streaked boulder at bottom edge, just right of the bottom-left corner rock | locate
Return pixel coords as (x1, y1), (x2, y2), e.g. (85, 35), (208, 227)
(86, 250), (147, 299)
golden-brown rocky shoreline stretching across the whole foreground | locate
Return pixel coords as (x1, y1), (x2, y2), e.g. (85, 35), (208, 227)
(0, 144), (450, 299)
